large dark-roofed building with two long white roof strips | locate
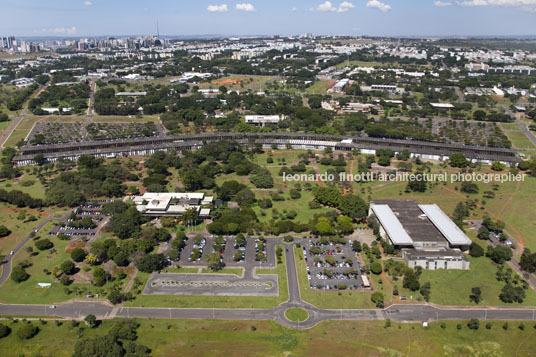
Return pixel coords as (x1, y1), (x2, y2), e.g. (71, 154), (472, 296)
(369, 200), (471, 270)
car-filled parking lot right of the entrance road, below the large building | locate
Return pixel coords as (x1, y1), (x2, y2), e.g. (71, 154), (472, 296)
(302, 238), (365, 290)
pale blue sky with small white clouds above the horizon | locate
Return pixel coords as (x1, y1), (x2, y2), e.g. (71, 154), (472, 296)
(0, 0), (536, 37)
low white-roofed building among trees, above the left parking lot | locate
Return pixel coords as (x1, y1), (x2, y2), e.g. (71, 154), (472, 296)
(133, 192), (214, 218)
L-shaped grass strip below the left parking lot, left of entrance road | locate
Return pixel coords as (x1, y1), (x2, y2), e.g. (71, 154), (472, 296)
(125, 245), (288, 309)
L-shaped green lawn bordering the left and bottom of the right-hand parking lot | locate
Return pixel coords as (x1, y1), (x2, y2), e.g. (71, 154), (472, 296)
(294, 247), (374, 309)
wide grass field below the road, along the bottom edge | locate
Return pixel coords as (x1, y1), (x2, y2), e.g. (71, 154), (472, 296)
(0, 319), (536, 357)
